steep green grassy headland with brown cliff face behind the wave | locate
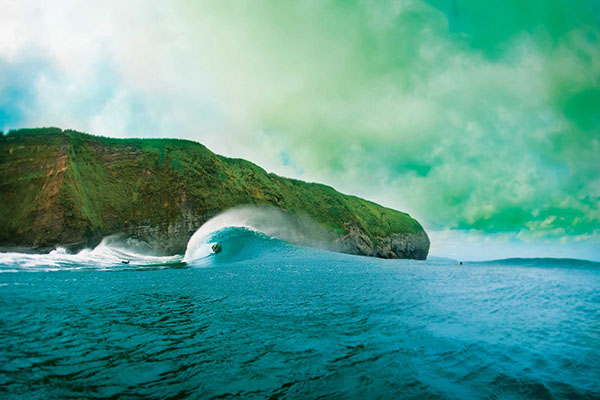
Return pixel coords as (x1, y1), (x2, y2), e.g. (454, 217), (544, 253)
(0, 128), (429, 259)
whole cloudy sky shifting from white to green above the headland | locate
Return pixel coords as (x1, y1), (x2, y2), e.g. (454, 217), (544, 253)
(0, 0), (600, 260)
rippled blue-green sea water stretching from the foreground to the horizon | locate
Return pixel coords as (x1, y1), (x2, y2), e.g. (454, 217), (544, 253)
(0, 228), (600, 399)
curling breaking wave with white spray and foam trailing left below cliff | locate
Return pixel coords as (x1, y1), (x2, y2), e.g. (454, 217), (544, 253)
(0, 206), (335, 272)
